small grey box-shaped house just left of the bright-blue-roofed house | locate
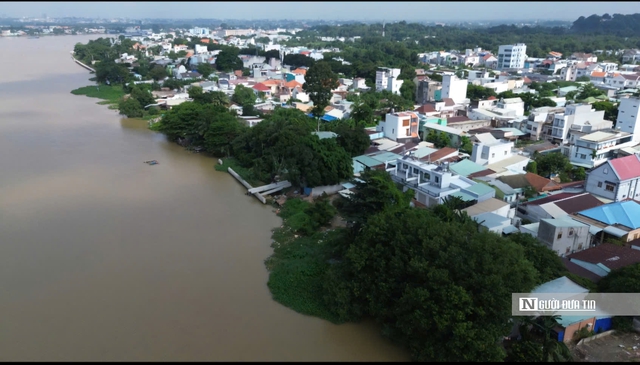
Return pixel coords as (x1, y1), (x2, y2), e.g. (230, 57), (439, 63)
(538, 216), (591, 256)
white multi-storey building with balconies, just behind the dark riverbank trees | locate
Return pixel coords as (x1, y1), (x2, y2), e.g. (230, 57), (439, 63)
(385, 155), (495, 207)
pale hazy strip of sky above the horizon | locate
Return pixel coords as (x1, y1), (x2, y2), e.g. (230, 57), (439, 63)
(0, 1), (640, 22)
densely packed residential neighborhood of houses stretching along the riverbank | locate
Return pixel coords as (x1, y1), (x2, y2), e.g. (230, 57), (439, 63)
(58, 14), (640, 362)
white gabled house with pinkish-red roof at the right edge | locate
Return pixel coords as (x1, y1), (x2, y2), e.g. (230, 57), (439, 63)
(585, 154), (640, 202)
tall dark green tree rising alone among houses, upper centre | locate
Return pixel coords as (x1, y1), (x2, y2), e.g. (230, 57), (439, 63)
(302, 61), (340, 118)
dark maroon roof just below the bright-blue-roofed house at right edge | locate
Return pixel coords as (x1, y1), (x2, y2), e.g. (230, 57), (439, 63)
(568, 240), (640, 270)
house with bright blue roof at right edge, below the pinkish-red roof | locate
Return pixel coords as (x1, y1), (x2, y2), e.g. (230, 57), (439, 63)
(571, 200), (640, 243)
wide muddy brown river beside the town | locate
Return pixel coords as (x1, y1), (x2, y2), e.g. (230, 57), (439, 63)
(0, 36), (408, 361)
